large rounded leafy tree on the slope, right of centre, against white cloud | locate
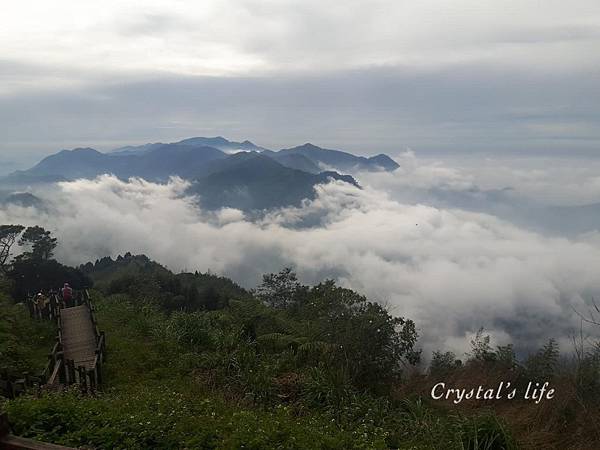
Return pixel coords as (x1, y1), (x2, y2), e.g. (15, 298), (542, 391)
(295, 280), (421, 389)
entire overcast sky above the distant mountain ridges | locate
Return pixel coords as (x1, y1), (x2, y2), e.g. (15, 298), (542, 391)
(0, 0), (600, 172)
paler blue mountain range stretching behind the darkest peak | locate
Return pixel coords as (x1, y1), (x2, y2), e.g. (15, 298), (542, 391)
(0, 136), (398, 187)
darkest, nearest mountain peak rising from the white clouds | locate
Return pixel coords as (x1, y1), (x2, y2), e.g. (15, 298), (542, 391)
(190, 153), (358, 211)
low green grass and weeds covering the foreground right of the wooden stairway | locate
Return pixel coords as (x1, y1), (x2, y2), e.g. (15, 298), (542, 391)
(5, 292), (516, 450)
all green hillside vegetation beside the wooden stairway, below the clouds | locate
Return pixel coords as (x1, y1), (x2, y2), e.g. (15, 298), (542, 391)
(0, 239), (600, 450)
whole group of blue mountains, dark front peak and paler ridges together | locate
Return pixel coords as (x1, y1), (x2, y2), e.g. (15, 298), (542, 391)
(0, 136), (390, 211)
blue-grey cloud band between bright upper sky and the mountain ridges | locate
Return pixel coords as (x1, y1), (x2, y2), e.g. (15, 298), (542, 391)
(0, 66), (600, 168)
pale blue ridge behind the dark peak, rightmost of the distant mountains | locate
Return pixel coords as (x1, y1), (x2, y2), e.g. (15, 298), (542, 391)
(276, 143), (400, 173)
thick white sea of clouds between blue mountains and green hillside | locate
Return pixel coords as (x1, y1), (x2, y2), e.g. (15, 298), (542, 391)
(0, 176), (600, 353)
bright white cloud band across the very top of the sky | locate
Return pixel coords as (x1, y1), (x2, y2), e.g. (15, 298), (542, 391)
(0, 0), (600, 93)
